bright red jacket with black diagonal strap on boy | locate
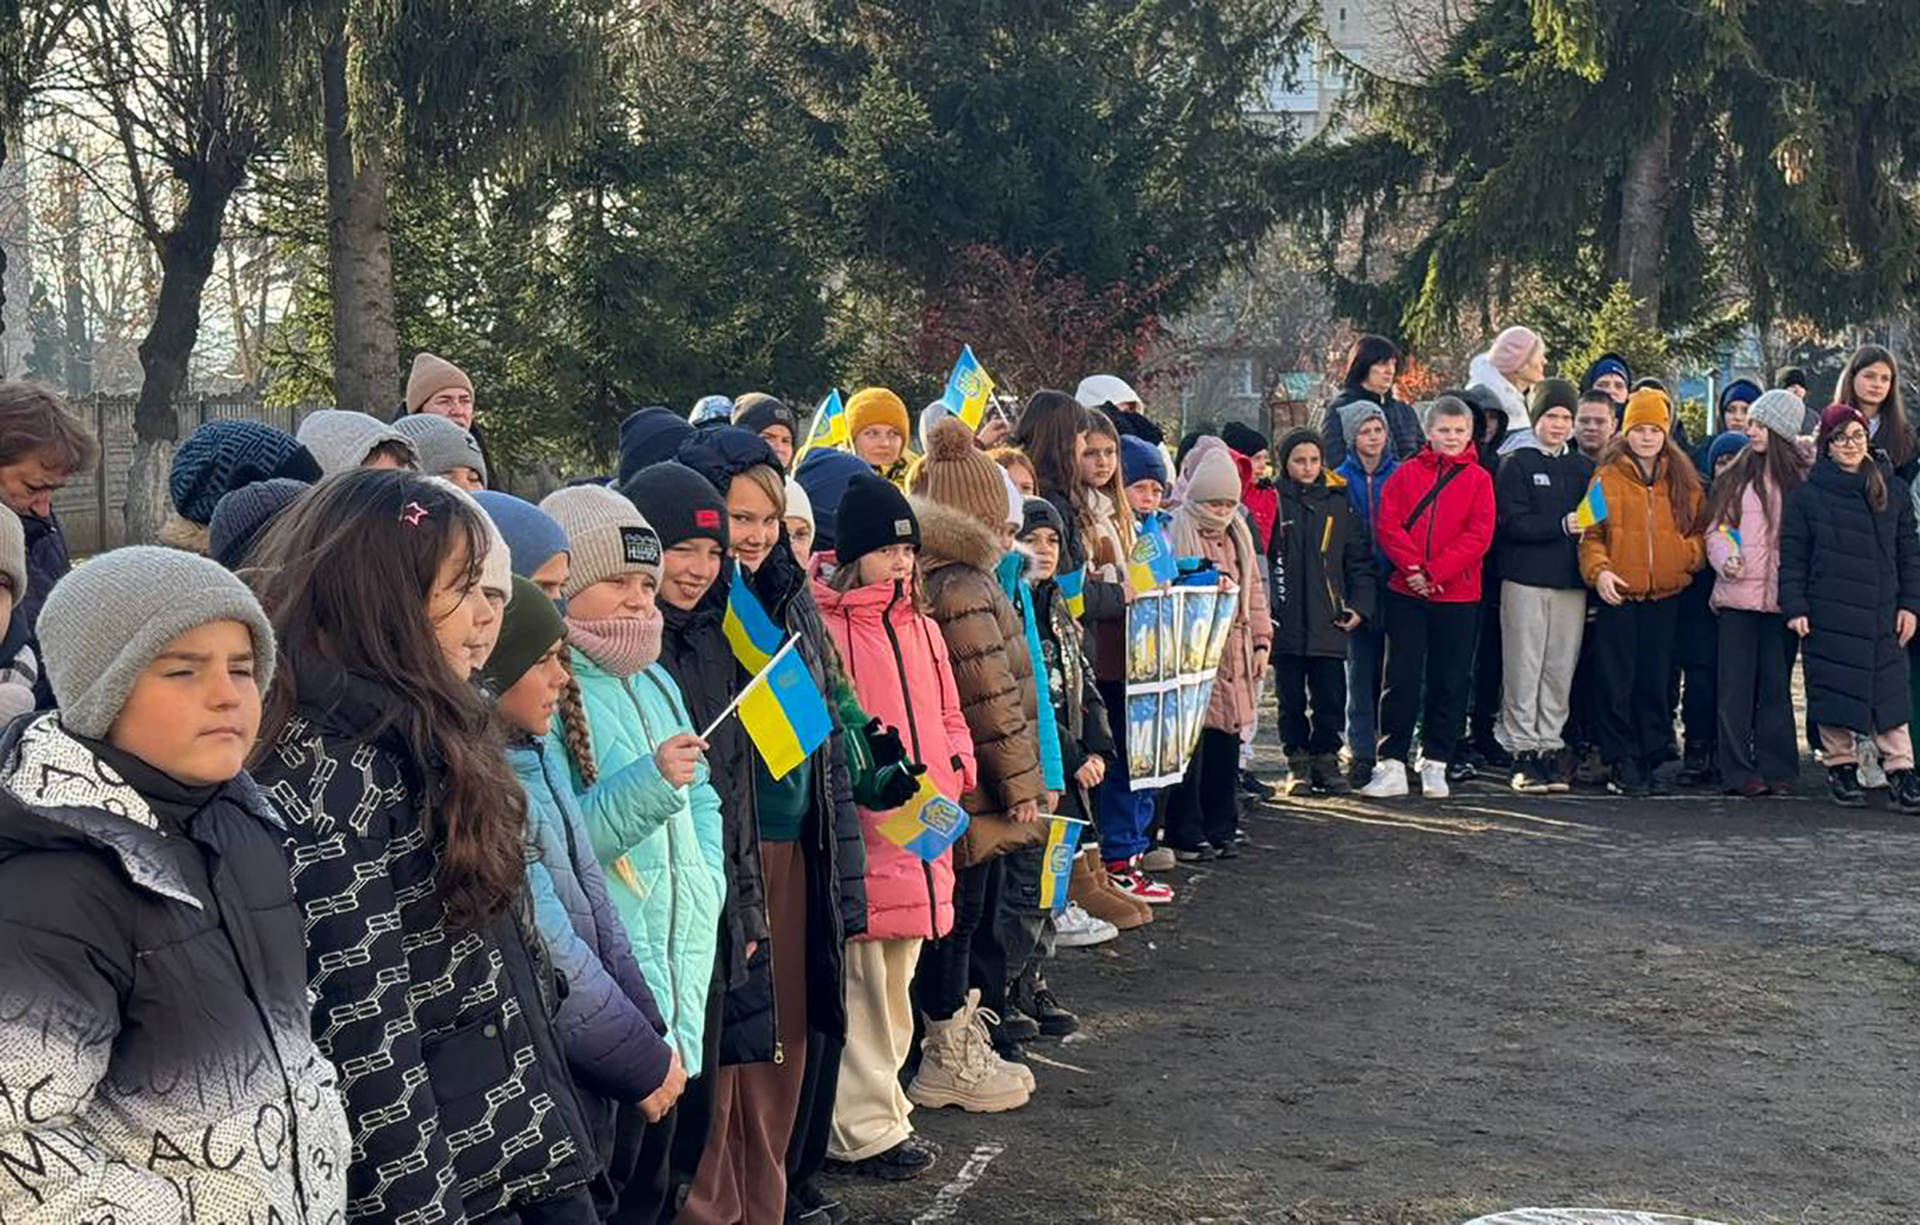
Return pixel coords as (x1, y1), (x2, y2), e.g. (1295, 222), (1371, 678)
(1373, 447), (1494, 605)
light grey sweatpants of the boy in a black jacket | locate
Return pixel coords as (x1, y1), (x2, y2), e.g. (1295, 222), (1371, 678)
(1498, 582), (1586, 753)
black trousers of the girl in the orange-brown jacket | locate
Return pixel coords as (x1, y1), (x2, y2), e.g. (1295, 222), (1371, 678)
(1594, 595), (1680, 770)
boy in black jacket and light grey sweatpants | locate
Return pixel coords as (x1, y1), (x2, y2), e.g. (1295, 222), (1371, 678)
(1494, 378), (1594, 791)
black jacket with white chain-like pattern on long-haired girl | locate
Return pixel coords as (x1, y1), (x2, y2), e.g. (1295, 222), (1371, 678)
(253, 659), (595, 1221)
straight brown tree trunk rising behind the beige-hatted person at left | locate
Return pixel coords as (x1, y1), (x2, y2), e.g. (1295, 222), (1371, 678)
(321, 26), (399, 420)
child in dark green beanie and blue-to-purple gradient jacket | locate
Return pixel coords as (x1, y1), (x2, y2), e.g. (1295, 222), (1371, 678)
(482, 578), (687, 1212)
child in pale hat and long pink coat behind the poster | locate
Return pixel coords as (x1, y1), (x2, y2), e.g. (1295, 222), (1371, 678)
(1167, 438), (1273, 860)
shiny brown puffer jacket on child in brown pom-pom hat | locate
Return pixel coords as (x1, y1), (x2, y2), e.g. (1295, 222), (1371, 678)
(908, 497), (1046, 868)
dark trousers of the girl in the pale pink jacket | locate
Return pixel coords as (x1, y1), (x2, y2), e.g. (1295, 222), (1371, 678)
(1720, 609), (1799, 785)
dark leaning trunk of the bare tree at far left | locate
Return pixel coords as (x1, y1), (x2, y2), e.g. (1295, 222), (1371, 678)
(127, 154), (246, 545)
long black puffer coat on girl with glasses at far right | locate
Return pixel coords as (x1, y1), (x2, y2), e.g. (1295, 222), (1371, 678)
(1780, 457), (1920, 732)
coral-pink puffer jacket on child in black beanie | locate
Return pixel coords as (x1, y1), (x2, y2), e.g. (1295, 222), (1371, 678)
(814, 582), (975, 941)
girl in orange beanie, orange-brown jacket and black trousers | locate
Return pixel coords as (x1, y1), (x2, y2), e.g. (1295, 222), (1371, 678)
(1580, 388), (1705, 797)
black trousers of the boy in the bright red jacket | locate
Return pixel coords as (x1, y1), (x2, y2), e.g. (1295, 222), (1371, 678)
(1380, 591), (1480, 762)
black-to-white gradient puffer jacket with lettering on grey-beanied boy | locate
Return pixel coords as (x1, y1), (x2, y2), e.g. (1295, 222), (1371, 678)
(0, 714), (349, 1225)
